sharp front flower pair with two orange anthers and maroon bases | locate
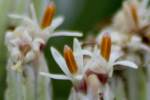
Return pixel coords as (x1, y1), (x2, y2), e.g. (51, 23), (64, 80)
(41, 33), (137, 100)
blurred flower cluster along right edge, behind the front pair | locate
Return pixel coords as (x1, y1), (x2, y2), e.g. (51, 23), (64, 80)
(97, 0), (150, 100)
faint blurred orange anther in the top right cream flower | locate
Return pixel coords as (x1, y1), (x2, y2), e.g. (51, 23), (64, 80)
(130, 3), (138, 25)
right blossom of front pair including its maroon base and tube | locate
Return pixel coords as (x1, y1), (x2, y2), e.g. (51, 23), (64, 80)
(86, 33), (137, 98)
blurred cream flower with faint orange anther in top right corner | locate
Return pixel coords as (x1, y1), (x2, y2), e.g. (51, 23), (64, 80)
(112, 0), (150, 37)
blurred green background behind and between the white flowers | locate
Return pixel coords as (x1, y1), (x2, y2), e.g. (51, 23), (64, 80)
(0, 0), (123, 100)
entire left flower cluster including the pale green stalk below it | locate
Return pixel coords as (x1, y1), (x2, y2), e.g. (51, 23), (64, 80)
(5, 3), (82, 100)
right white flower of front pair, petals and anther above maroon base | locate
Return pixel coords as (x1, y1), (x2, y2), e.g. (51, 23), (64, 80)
(86, 33), (137, 77)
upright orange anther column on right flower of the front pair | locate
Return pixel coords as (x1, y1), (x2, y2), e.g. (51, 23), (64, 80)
(100, 33), (111, 61)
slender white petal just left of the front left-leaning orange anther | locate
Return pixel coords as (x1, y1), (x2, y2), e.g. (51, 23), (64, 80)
(51, 47), (71, 76)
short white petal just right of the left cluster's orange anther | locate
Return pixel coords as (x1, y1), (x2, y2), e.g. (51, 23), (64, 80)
(46, 16), (64, 32)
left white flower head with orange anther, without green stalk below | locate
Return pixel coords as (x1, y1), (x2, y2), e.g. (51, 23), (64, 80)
(5, 4), (82, 70)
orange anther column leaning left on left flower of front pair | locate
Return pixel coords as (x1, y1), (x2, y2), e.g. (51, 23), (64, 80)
(64, 45), (78, 74)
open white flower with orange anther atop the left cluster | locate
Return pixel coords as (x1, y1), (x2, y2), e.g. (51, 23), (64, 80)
(9, 4), (82, 41)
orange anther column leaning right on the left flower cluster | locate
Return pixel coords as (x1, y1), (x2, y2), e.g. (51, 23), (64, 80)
(41, 2), (56, 28)
